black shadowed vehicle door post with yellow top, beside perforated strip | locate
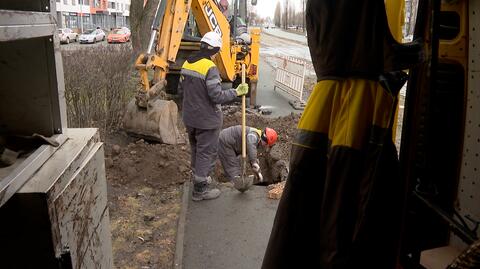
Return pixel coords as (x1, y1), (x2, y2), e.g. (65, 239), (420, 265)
(400, 0), (471, 268)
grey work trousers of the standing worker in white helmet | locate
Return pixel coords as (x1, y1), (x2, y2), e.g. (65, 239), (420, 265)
(186, 126), (220, 178)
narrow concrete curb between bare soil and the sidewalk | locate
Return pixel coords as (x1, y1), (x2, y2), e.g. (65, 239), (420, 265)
(173, 181), (190, 269)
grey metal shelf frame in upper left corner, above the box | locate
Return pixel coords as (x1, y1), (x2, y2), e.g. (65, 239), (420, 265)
(0, 0), (67, 207)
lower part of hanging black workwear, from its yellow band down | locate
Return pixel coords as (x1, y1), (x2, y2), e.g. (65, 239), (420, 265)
(262, 78), (404, 268)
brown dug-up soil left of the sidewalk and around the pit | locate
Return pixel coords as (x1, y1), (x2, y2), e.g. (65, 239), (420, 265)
(105, 110), (299, 268)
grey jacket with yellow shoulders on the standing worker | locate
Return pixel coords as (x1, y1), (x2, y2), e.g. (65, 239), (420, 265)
(178, 58), (237, 129)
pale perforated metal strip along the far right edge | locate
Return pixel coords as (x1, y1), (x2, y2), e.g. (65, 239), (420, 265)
(458, 1), (480, 237)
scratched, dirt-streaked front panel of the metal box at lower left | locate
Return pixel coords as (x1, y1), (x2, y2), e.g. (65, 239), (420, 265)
(49, 143), (113, 269)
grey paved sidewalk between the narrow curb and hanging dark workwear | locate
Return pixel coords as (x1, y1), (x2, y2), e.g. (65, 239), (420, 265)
(175, 183), (278, 269)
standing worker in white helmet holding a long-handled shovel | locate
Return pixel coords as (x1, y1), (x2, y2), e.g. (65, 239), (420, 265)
(178, 32), (248, 201)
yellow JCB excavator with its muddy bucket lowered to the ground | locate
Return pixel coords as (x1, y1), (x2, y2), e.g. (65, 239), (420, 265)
(124, 0), (260, 144)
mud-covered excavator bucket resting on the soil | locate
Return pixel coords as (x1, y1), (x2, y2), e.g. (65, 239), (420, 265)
(123, 98), (185, 145)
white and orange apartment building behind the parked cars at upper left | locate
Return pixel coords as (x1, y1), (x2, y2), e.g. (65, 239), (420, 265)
(56, 0), (130, 32)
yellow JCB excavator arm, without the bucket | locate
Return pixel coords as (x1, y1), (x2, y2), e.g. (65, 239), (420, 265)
(135, 0), (260, 92)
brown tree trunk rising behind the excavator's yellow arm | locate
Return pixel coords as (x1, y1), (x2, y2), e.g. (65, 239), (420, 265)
(130, 0), (159, 54)
